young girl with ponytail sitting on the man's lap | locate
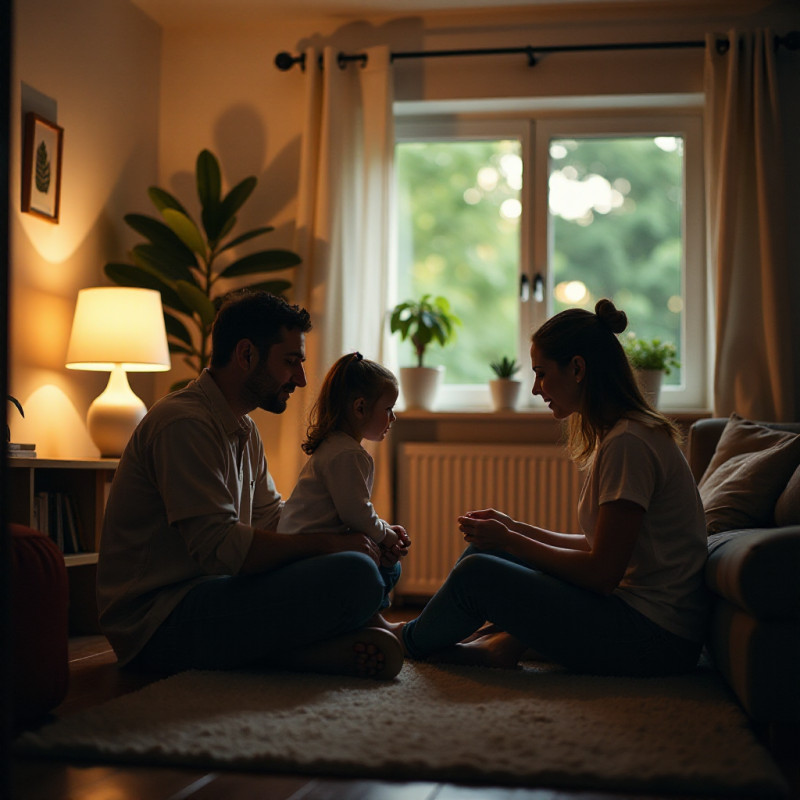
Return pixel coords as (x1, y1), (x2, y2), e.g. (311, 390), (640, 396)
(278, 353), (410, 626)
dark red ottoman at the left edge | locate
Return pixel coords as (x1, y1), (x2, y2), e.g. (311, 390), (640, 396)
(9, 524), (69, 728)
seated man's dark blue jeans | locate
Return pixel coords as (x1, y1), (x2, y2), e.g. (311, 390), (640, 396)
(131, 551), (400, 673)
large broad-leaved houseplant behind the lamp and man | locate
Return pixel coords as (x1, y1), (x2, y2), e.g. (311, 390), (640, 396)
(105, 150), (300, 389)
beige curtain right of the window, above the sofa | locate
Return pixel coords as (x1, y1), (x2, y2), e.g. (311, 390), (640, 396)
(705, 30), (796, 421)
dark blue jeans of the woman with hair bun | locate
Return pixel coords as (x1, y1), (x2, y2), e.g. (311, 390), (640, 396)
(403, 547), (701, 675)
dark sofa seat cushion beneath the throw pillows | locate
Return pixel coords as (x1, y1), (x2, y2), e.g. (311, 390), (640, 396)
(705, 526), (800, 621)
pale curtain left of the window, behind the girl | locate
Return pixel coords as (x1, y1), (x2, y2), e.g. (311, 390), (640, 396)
(281, 46), (394, 513)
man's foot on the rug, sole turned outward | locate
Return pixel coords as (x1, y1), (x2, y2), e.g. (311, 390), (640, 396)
(275, 628), (403, 680)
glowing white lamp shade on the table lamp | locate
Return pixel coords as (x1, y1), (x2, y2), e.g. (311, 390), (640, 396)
(67, 286), (170, 372)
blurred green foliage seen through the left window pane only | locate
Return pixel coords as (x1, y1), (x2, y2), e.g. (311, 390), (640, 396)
(397, 141), (520, 384)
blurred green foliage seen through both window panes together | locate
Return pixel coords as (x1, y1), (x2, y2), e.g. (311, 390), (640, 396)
(397, 136), (683, 384)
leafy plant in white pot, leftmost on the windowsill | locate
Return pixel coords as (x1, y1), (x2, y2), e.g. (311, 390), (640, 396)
(389, 294), (461, 411)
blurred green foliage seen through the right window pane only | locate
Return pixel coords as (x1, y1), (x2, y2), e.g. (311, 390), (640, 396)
(550, 137), (683, 384)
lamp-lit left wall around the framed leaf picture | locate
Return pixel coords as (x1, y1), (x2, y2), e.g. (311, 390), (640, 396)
(9, 0), (161, 457)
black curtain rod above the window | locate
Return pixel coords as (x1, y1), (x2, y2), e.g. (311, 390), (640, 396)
(275, 31), (800, 72)
